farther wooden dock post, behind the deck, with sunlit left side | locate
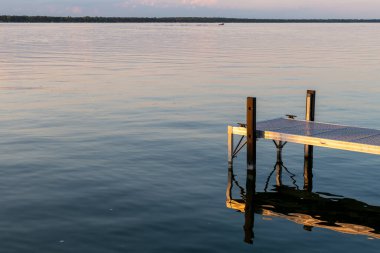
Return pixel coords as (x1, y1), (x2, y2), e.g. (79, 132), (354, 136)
(303, 90), (315, 192)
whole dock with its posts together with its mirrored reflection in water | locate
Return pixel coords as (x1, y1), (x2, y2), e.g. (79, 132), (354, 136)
(226, 90), (380, 243)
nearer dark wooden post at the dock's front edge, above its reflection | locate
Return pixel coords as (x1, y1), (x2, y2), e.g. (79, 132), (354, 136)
(247, 97), (257, 170)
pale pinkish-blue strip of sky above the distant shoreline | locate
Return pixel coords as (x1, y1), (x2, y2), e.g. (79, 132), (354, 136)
(0, 0), (380, 18)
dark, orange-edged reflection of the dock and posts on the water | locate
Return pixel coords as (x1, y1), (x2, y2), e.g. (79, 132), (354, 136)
(226, 152), (380, 244)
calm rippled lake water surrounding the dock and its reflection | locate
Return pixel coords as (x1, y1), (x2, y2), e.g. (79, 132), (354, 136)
(0, 24), (380, 253)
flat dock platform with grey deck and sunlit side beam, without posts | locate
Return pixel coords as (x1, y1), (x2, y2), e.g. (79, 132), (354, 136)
(231, 118), (380, 155)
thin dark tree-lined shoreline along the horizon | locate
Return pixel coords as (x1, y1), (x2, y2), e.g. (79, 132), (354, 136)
(0, 15), (380, 23)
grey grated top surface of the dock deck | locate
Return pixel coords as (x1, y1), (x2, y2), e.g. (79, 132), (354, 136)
(257, 118), (380, 146)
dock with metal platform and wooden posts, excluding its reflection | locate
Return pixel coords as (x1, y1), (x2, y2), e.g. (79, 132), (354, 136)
(228, 90), (380, 170)
